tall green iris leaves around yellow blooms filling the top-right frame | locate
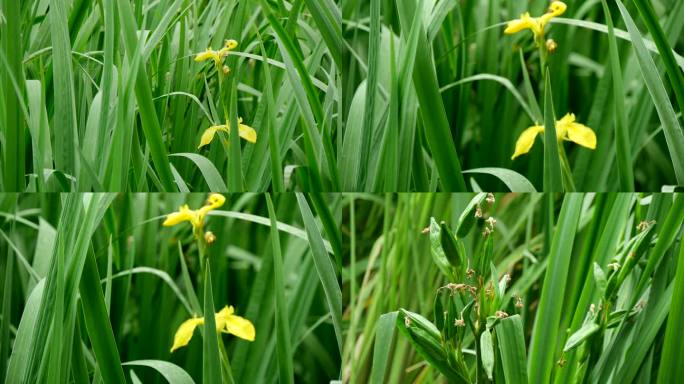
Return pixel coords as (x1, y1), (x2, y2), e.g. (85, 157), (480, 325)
(340, 0), (684, 192)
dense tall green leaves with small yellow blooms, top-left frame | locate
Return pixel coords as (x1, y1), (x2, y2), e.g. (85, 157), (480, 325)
(0, 0), (342, 192)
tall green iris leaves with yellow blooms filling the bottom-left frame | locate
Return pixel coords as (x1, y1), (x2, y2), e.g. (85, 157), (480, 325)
(0, 193), (342, 383)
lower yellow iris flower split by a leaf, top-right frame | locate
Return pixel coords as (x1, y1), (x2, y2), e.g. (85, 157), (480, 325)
(511, 113), (596, 160)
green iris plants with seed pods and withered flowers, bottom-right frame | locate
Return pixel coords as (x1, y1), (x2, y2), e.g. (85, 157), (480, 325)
(343, 194), (684, 383)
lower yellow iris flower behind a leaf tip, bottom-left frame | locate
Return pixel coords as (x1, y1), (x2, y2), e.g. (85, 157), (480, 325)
(171, 305), (256, 352)
